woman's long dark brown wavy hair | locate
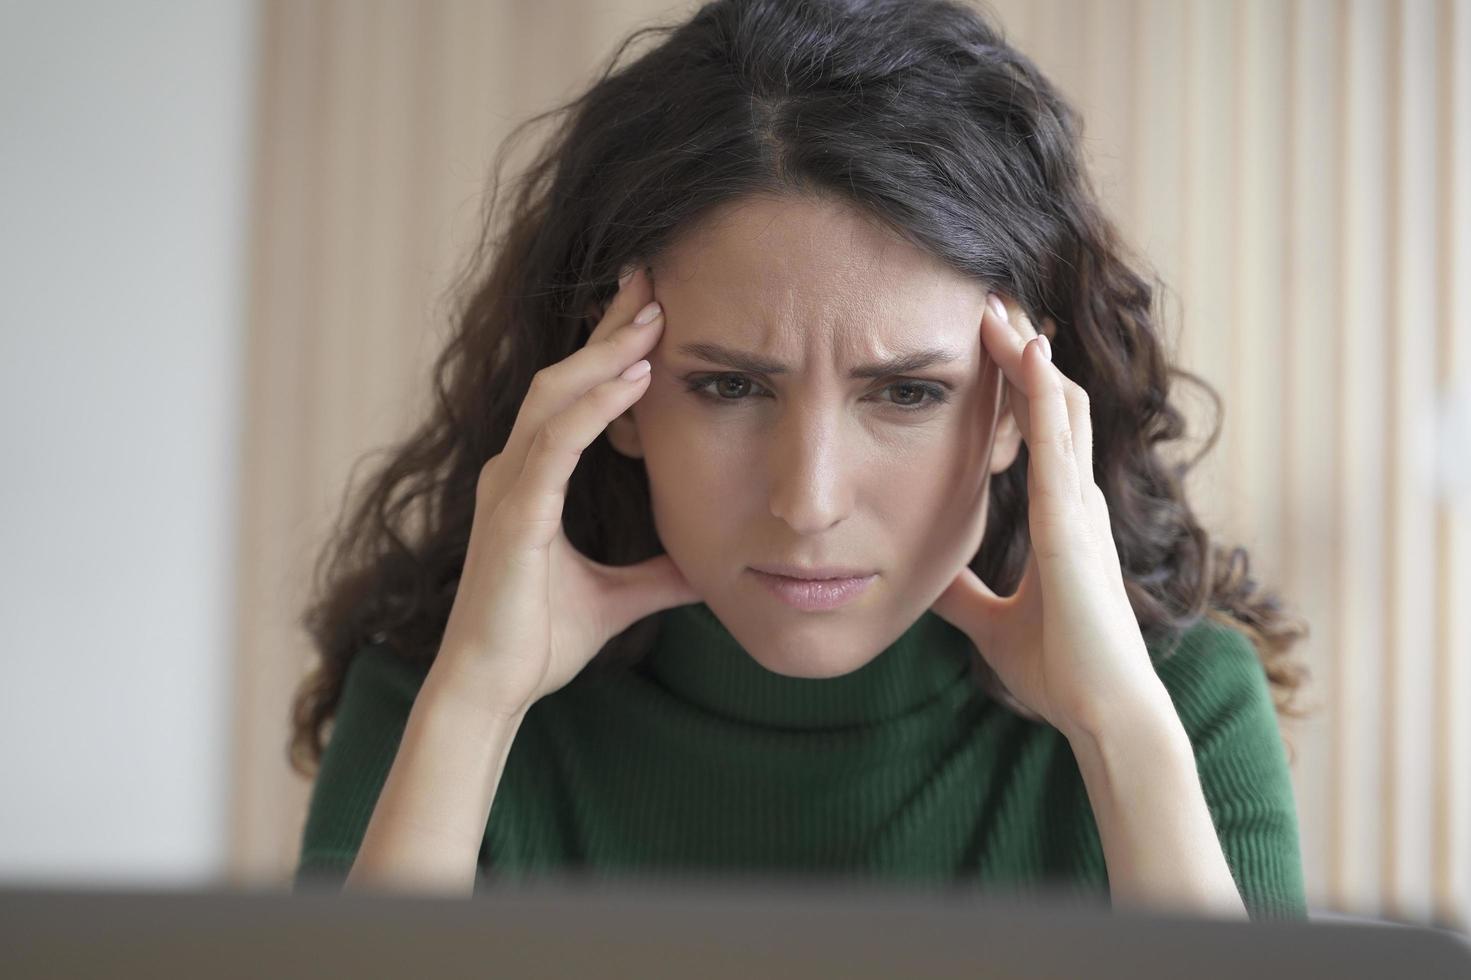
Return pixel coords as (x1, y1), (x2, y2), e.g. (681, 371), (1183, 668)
(290, 0), (1308, 775)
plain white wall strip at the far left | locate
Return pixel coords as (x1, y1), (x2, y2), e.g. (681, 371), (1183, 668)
(0, 0), (257, 886)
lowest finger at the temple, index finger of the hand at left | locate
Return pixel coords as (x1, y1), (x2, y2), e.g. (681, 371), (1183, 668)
(496, 357), (652, 552)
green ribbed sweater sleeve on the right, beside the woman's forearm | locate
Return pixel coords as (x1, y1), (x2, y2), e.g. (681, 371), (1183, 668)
(1156, 621), (1308, 920)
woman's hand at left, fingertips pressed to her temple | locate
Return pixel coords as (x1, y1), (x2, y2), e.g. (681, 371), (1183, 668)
(440, 268), (699, 717)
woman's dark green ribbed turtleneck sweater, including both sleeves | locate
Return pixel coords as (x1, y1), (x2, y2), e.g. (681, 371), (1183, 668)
(296, 603), (1306, 918)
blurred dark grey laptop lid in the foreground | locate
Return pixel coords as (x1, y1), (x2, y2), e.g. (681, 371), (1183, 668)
(0, 874), (1471, 980)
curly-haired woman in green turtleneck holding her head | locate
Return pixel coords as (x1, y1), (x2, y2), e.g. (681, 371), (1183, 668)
(293, 0), (1305, 918)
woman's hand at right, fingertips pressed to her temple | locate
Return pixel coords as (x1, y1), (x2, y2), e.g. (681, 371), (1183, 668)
(933, 293), (1169, 737)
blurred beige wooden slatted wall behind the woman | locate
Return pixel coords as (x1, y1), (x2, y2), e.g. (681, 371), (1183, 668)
(231, 0), (1471, 928)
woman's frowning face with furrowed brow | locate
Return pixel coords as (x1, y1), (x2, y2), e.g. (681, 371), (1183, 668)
(608, 197), (1019, 677)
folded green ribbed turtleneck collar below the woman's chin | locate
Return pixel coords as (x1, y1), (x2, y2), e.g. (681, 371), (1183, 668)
(643, 602), (975, 730)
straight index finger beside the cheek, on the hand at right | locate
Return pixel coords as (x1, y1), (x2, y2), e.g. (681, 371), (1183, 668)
(1021, 329), (1089, 559)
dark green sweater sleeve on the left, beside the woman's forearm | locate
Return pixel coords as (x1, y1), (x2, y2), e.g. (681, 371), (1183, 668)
(293, 646), (427, 892)
